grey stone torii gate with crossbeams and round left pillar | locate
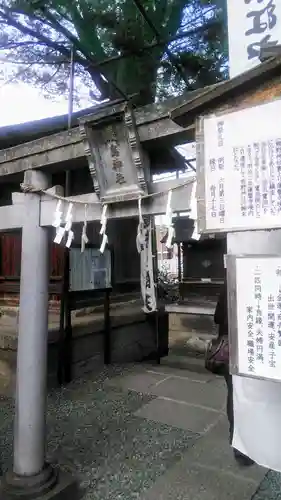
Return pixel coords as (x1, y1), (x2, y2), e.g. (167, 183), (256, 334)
(0, 96), (194, 499)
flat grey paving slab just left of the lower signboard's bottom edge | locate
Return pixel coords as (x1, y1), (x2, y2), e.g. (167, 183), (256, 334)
(150, 377), (226, 411)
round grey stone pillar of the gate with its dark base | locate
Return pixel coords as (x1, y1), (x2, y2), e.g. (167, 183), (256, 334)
(0, 170), (78, 500)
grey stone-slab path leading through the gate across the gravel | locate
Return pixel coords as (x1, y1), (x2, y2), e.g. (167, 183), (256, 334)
(106, 367), (267, 500)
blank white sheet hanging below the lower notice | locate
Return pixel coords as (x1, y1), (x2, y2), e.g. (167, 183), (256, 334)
(232, 376), (281, 472)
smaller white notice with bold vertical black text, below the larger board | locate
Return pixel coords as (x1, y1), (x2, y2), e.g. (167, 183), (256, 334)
(230, 256), (281, 381)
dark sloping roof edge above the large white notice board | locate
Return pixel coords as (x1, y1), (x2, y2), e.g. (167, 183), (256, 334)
(169, 56), (281, 127)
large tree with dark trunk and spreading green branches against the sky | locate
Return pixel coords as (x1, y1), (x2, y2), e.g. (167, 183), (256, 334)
(0, 0), (227, 105)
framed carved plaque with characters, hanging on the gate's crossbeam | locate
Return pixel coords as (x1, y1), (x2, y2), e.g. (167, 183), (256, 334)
(77, 106), (149, 203)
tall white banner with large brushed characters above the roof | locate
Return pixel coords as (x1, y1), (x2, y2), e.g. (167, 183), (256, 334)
(227, 0), (281, 78)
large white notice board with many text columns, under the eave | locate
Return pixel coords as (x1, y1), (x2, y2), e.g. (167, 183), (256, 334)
(197, 99), (281, 233)
